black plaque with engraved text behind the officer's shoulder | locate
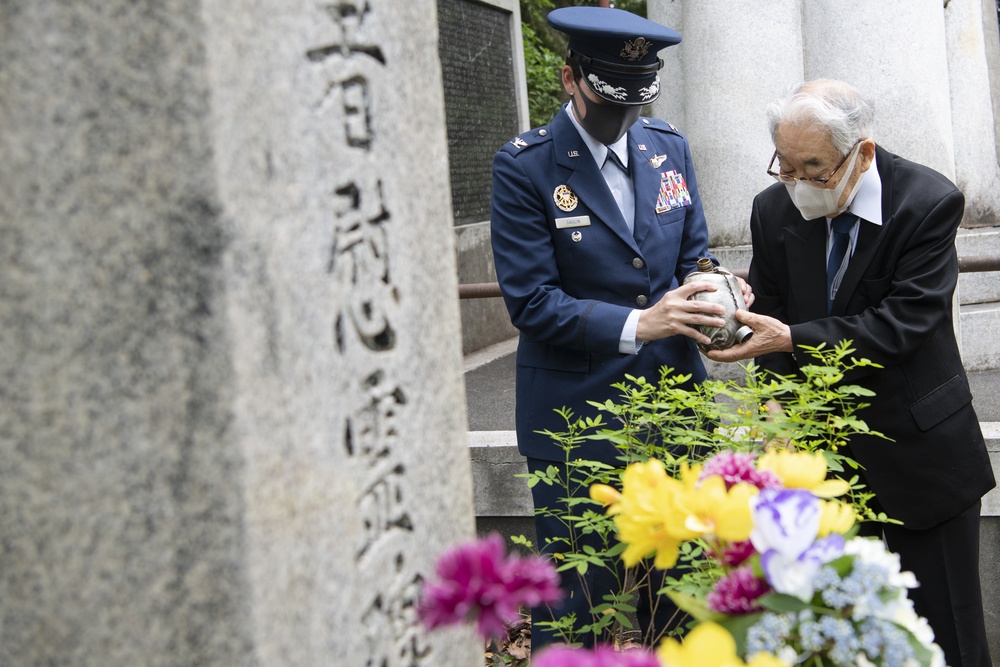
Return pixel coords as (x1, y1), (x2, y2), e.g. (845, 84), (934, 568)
(438, 0), (520, 225)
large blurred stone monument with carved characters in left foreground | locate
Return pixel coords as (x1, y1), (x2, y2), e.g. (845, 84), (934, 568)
(0, 0), (482, 667)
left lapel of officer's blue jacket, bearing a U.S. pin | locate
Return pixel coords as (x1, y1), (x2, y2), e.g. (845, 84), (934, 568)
(550, 107), (638, 250)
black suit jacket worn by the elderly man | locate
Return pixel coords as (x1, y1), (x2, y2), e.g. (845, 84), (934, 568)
(749, 147), (995, 529)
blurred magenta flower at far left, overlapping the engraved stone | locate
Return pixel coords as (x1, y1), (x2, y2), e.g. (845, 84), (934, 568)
(417, 534), (562, 638)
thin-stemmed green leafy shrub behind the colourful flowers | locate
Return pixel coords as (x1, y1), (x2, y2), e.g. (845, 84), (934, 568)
(518, 341), (891, 645)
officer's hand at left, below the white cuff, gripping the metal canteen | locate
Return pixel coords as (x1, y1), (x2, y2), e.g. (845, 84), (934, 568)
(635, 281), (726, 345)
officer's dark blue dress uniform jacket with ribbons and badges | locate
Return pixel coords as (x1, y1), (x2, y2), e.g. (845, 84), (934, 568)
(491, 107), (708, 463)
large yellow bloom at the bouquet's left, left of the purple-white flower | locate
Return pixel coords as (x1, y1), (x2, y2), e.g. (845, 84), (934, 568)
(598, 459), (697, 569)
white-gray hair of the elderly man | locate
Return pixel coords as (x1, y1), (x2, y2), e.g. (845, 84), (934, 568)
(767, 79), (875, 154)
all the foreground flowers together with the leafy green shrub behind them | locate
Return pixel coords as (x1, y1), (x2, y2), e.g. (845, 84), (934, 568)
(418, 342), (944, 667)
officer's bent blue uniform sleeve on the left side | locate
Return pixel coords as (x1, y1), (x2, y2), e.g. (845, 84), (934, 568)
(490, 150), (632, 354)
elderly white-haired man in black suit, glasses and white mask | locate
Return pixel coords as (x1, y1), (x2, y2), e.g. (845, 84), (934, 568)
(708, 80), (995, 667)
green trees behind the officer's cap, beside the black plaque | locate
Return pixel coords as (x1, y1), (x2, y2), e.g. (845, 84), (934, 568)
(520, 0), (652, 127)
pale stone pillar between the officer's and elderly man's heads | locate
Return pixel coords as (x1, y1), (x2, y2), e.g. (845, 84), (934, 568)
(649, 0), (803, 246)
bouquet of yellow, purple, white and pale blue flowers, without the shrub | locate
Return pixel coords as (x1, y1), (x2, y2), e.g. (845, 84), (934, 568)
(591, 450), (944, 667)
